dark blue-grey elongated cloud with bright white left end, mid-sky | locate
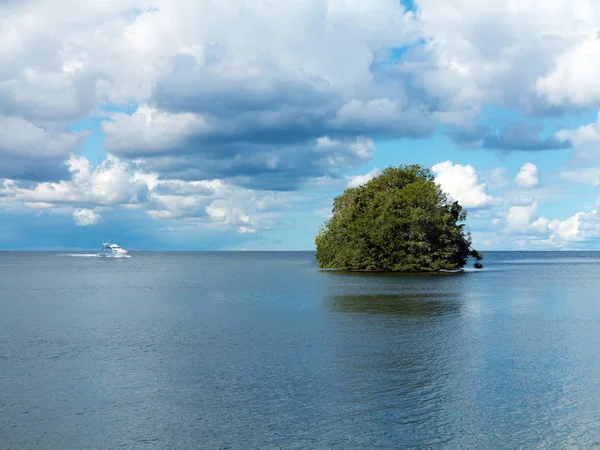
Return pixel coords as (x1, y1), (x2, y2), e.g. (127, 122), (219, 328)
(102, 107), (375, 190)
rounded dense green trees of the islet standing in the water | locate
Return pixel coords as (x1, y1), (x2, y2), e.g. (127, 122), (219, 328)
(315, 165), (482, 272)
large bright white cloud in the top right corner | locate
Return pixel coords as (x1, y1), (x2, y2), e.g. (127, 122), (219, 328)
(410, 0), (600, 114)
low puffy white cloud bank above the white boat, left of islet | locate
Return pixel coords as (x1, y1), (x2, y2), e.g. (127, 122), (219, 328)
(0, 155), (298, 234)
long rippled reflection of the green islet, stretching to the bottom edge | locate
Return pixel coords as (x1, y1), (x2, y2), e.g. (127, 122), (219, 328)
(326, 292), (473, 448)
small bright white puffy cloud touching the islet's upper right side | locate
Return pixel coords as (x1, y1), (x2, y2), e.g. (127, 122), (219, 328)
(431, 161), (494, 208)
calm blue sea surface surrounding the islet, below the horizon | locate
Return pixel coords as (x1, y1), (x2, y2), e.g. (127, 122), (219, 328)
(0, 252), (600, 449)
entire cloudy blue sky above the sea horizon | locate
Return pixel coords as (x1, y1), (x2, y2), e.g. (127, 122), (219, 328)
(0, 0), (600, 251)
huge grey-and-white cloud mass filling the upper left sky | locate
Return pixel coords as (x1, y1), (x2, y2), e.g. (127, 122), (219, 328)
(0, 0), (426, 190)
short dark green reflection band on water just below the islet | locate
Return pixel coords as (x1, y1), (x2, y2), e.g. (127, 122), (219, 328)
(328, 293), (461, 316)
